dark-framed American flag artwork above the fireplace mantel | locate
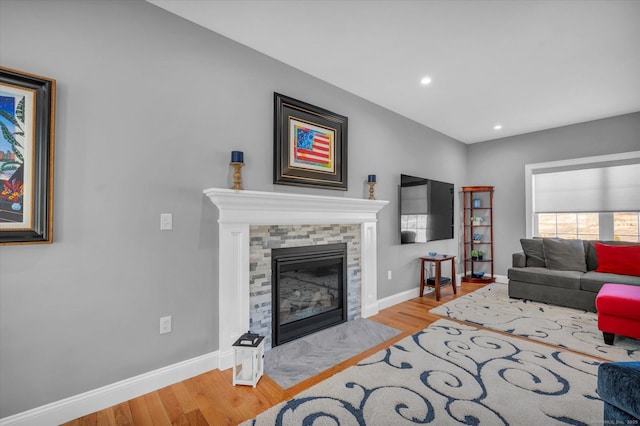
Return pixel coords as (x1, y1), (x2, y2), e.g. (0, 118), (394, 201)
(273, 93), (347, 191)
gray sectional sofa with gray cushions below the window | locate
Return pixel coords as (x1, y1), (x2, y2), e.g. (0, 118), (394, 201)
(508, 238), (640, 312)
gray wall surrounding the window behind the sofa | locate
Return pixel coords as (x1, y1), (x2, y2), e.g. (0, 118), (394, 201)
(468, 113), (640, 275)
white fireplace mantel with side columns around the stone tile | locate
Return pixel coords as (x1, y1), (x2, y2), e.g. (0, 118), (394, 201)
(204, 188), (389, 370)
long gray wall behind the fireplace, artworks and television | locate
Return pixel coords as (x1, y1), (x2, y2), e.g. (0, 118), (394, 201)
(0, 0), (467, 417)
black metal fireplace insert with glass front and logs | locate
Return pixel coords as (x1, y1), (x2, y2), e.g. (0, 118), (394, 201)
(271, 243), (347, 346)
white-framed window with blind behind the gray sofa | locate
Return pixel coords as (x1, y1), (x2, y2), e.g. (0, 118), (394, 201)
(525, 151), (640, 242)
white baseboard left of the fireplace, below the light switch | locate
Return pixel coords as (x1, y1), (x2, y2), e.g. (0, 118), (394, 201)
(0, 352), (218, 426)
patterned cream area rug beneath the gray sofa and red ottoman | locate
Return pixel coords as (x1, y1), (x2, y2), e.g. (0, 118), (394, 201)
(429, 283), (640, 361)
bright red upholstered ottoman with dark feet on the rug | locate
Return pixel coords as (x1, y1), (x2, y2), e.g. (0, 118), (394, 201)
(596, 283), (640, 345)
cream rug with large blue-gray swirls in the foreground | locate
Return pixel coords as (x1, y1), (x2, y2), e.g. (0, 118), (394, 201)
(243, 319), (603, 426)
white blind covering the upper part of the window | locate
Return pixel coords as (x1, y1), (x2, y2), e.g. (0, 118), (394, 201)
(532, 163), (640, 213)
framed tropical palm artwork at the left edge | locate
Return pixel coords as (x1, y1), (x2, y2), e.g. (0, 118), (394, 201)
(0, 67), (56, 245)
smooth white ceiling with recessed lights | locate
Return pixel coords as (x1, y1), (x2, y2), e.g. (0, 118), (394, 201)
(147, 0), (640, 143)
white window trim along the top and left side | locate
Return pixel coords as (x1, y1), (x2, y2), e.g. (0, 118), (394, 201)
(524, 151), (640, 238)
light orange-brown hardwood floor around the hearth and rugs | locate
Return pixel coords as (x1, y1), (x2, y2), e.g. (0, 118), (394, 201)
(65, 283), (483, 426)
